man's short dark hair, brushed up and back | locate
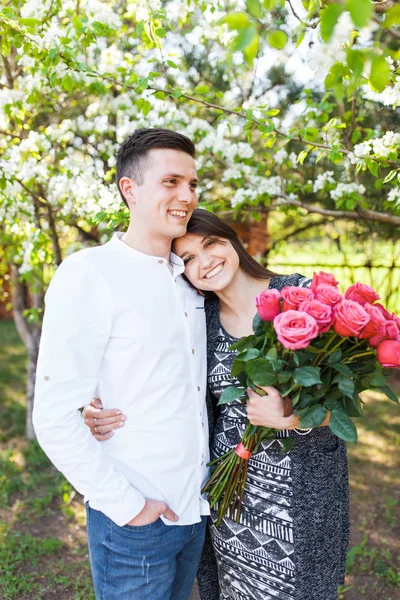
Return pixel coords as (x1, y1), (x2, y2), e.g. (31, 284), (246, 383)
(117, 128), (196, 205)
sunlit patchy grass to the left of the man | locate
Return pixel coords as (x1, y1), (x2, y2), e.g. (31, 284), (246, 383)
(0, 321), (94, 600)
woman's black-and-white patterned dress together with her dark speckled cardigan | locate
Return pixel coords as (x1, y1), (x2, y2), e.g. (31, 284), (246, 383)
(197, 274), (349, 600)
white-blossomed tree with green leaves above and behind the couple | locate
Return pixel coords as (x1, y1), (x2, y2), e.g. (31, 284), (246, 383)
(0, 0), (400, 436)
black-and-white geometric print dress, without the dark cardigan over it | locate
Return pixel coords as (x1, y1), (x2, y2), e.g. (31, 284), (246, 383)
(208, 326), (300, 600)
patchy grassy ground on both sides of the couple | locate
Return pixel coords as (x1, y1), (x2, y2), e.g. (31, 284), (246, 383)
(0, 321), (400, 600)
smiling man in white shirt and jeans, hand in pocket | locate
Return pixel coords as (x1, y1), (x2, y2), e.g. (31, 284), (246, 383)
(33, 129), (209, 600)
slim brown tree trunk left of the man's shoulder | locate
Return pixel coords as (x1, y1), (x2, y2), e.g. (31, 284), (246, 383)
(11, 266), (44, 440)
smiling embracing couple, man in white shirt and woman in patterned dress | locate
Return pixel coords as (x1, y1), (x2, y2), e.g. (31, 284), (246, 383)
(34, 129), (349, 600)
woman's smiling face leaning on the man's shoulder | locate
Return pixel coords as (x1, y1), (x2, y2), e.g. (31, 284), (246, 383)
(174, 233), (239, 292)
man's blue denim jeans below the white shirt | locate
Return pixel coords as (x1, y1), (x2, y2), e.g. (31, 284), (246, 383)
(86, 504), (207, 600)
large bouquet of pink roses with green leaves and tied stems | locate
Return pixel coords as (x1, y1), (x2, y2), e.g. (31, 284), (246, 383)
(203, 271), (400, 524)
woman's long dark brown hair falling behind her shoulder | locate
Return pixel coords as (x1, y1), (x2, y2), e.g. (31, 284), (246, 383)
(183, 208), (276, 279)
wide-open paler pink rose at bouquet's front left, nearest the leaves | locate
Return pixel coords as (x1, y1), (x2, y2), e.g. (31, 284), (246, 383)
(274, 310), (319, 350)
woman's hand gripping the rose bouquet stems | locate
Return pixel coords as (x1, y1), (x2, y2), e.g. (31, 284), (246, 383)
(247, 386), (300, 429)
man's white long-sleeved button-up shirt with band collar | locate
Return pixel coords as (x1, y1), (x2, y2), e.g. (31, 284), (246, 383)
(33, 234), (209, 525)
